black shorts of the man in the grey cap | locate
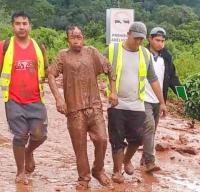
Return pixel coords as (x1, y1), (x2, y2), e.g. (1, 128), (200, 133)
(108, 108), (145, 152)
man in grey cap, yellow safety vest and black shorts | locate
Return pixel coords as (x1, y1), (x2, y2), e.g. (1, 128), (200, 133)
(105, 22), (166, 183)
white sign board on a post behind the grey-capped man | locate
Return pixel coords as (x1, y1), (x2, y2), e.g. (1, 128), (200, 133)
(106, 8), (134, 44)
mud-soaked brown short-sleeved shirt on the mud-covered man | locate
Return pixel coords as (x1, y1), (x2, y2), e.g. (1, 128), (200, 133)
(49, 46), (115, 113)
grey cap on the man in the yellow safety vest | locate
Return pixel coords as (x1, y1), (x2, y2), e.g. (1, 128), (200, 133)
(129, 21), (147, 38)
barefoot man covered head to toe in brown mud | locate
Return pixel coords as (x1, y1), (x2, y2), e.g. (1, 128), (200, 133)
(48, 26), (118, 190)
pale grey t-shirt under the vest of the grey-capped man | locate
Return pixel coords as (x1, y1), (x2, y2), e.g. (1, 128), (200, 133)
(115, 48), (157, 111)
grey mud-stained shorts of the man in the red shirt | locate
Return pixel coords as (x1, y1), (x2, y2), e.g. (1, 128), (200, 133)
(5, 100), (47, 141)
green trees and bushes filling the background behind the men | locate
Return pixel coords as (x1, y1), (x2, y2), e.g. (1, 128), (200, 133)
(0, 0), (200, 118)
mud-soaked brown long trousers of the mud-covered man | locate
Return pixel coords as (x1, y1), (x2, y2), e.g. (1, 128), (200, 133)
(67, 108), (107, 181)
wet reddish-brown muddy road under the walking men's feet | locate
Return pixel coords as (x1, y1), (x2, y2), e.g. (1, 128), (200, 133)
(0, 86), (200, 192)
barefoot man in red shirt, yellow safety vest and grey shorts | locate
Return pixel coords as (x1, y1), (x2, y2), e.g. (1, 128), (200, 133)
(0, 12), (47, 184)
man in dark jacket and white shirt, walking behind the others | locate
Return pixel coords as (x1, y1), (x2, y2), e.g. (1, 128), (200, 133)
(141, 27), (180, 172)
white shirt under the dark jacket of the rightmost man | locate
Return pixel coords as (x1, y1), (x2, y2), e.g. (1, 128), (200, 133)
(144, 54), (165, 103)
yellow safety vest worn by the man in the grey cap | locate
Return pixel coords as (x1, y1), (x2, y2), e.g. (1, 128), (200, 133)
(108, 42), (150, 101)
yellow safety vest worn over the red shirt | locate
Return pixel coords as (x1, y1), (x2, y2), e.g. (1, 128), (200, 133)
(0, 37), (45, 102)
